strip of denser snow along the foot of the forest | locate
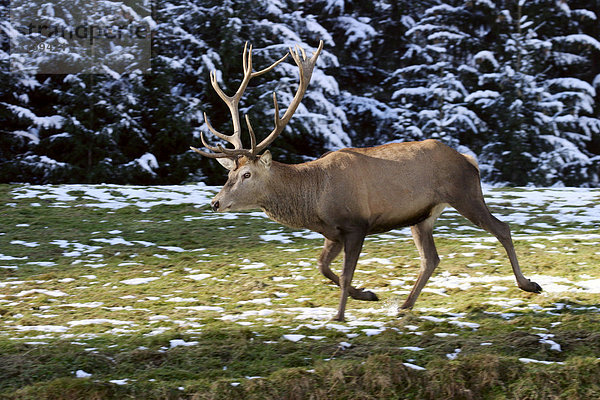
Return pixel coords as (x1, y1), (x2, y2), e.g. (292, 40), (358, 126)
(12, 184), (600, 234)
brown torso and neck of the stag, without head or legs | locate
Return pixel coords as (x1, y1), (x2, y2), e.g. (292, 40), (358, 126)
(255, 140), (466, 236)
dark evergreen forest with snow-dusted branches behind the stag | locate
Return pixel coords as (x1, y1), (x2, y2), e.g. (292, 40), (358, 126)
(0, 0), (600, 187)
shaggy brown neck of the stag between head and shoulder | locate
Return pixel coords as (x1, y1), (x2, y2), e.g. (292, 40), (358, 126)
(260, 162), (322, 230)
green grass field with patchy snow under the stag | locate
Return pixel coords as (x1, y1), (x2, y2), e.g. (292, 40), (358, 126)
(0, 185), (600, 399)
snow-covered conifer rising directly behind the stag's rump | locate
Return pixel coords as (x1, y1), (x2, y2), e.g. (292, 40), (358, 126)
(391, 2), (483, 151)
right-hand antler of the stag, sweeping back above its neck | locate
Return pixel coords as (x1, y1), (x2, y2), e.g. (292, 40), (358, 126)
(256, 40), (323, 153)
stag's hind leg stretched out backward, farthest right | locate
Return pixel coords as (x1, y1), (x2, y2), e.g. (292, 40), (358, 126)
(452, 190), (542, 293)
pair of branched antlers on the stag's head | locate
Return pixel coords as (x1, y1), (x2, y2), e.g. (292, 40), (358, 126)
(191, 40), (323, 158)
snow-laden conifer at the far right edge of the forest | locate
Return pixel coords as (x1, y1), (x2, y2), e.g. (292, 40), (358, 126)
(466, 1), (597, 185)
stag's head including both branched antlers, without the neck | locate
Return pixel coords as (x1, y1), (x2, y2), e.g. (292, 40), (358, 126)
(191, 40), (323, 212)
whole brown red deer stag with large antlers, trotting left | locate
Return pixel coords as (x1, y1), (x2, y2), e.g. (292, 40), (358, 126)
(192, 41), (542, 321)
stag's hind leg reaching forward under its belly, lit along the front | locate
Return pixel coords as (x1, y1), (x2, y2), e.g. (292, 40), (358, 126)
(401, 204), (446, 309)
